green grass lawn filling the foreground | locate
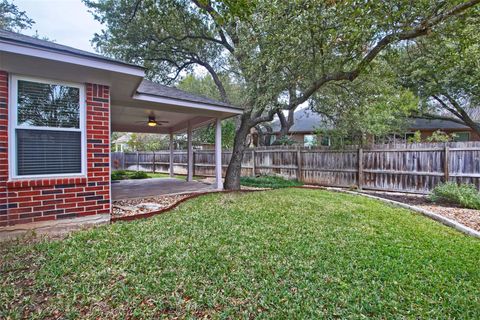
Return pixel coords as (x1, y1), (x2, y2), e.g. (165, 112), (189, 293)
(0, 189), (480, 319)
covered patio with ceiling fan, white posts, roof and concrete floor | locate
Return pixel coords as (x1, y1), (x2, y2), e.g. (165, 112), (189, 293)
(110, 80), (242, 196)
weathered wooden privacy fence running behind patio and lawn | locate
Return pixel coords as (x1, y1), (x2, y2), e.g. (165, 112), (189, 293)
(112, 142), (480, 193)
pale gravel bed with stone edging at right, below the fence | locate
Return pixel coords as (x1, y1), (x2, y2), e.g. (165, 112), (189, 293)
(364, 191), (480, 231)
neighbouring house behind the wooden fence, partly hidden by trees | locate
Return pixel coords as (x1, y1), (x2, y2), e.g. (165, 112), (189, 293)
(271, 108), (480, 146)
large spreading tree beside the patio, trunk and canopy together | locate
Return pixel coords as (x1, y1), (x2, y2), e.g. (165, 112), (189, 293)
(84, 0), (480, 189)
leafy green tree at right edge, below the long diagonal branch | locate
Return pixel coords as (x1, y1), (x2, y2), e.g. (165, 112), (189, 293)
(389, 12), (480, 134)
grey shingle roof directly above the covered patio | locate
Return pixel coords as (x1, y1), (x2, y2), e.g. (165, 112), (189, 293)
(137, 80), (240, 109)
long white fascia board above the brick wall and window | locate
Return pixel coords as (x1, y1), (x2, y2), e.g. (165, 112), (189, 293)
(0, 42), (145, 78)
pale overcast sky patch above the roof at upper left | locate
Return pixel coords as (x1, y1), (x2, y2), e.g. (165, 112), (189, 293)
(13, 0), (102, 52)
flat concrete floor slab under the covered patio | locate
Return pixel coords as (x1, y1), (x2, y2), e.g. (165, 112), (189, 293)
(112, 178), (215, 200)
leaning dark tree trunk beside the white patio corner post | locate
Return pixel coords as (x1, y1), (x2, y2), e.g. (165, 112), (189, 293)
(224, 114), (252, 190)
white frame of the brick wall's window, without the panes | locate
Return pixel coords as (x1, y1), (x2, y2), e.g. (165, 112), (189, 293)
(8, 75), (87, 180)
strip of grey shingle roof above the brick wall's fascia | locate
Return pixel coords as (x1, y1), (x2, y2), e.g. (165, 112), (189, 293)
(0, 29), (143, 69)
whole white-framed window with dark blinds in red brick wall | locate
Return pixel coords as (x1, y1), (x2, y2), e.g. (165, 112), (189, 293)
(12, 77), (84, 177)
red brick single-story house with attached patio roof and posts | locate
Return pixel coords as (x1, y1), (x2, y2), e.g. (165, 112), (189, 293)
(0, 30), (242, 236)
